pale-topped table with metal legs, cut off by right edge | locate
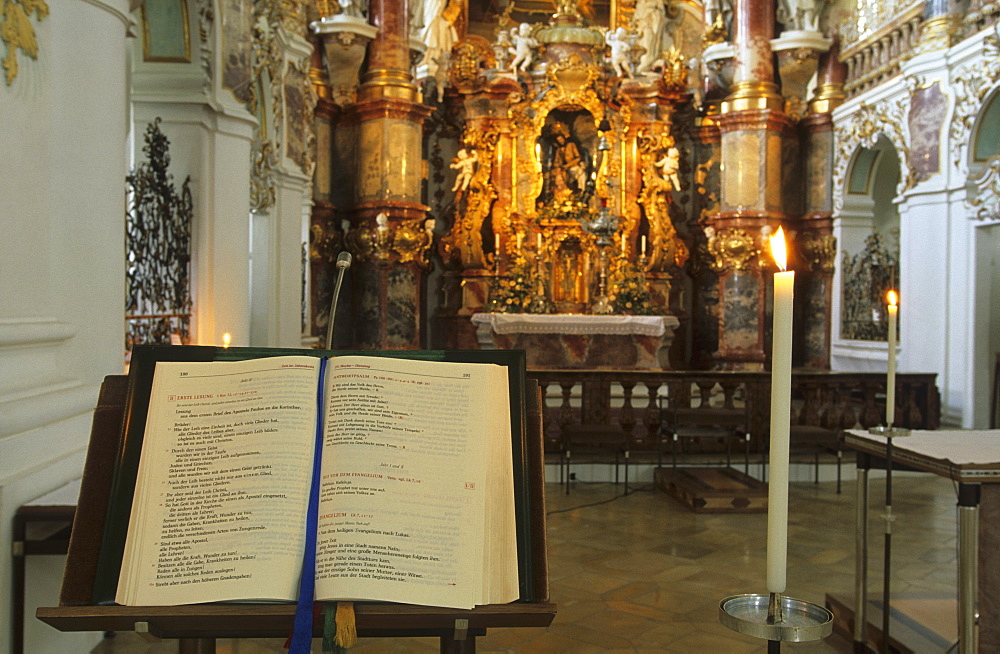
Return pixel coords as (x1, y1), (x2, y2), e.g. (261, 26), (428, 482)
(844, 429), (1000, 654)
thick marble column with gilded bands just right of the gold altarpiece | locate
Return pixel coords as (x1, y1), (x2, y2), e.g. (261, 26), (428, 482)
(708, 0), (795, 370)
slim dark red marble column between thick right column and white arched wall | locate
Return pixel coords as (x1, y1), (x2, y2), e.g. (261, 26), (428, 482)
(794, 42), (847, 369)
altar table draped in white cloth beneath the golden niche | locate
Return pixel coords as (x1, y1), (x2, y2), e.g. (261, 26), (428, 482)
(472, 313), (680, 370)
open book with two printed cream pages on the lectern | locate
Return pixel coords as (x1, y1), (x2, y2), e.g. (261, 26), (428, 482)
(114, 356), (519, 608)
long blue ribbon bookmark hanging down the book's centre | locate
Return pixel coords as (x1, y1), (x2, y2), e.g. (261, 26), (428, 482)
(288, 358), (326, 654)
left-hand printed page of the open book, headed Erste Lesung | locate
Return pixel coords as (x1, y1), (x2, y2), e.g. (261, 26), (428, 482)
(116, 357), (320, 606)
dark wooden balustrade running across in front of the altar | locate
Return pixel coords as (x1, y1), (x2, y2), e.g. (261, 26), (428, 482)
(528, 369), (940, 452)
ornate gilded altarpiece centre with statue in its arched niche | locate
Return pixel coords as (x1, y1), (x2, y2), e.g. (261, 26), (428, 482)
(438, 3), (688, 368)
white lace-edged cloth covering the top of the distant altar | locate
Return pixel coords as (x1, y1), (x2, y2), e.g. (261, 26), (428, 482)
(472, 313), (680, 336)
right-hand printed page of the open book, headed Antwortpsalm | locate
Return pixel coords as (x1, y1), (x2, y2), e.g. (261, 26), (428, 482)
(316, 357), (510, 608)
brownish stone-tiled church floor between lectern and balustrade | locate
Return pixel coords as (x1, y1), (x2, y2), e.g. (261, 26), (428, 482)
(93, 474), (957, 654)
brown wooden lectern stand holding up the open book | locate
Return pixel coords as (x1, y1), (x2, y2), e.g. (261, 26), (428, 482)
(36, 352), (556, 654)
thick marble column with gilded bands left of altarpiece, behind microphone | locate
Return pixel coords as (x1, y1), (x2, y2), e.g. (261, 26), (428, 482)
(346, 0), (433, 349)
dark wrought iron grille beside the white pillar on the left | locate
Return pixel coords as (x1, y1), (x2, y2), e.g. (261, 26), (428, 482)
(125, 118), (193, 360)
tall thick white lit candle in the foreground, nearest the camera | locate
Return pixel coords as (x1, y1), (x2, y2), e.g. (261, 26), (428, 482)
(767, 227), (795, 593)
